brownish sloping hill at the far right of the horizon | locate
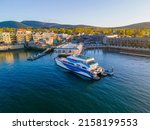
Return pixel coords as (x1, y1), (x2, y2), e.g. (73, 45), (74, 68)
(117, 22), (150, 29)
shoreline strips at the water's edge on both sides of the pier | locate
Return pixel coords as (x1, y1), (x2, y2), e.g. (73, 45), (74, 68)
(0, 44), (150, 58)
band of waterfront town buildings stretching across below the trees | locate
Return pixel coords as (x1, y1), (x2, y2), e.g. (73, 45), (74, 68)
(0, 29), (150, 48)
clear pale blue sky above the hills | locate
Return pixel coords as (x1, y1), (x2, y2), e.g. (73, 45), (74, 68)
(0, 0), (150, 27)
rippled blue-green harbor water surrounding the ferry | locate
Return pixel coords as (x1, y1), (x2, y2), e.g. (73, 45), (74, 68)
(0, 50), (150, 113)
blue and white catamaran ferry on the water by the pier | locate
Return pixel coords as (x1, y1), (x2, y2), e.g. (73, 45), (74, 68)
(55, 55), (105, 80)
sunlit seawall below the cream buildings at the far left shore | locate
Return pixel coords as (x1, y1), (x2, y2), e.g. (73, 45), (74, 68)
(0, 45), (24, 51)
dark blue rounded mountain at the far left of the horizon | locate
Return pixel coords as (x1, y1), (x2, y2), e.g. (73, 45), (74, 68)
(0, 21), (30, 28)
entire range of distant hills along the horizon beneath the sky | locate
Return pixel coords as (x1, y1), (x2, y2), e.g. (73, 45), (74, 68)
(0, 21), (150, 29)
